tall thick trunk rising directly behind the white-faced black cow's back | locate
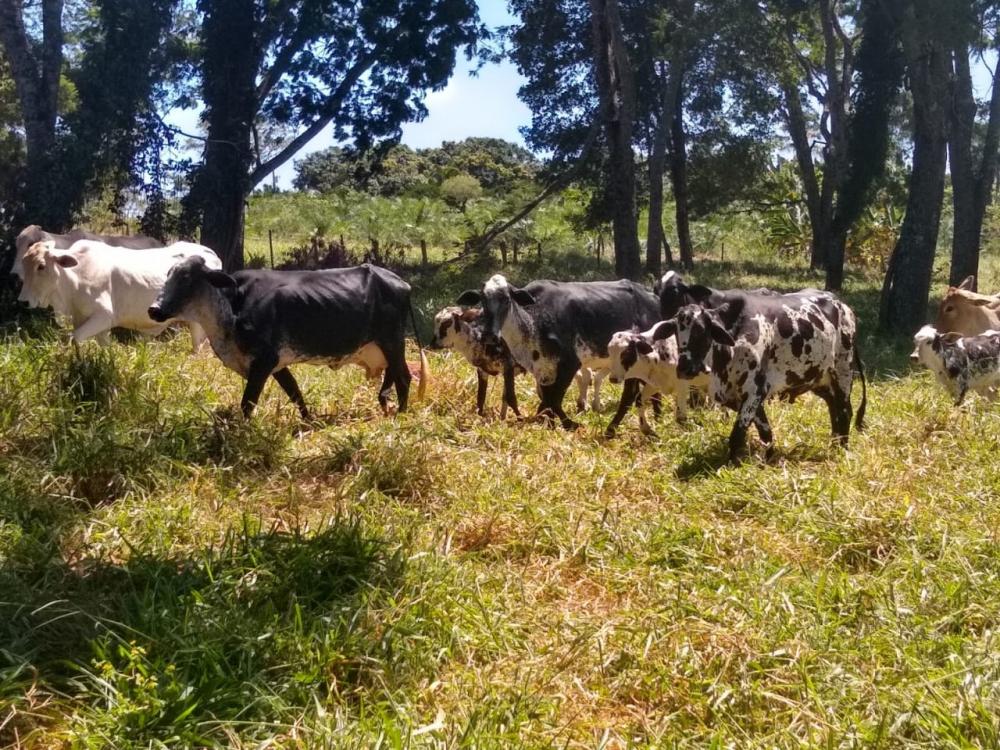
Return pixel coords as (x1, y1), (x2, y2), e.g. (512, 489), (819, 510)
(590, 0), (642, 279)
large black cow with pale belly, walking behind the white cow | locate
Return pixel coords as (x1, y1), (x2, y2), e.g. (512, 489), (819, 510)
(149, 257), (427, 418)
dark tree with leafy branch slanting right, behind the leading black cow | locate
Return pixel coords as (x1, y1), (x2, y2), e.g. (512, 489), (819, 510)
(184, 0), (484, 269)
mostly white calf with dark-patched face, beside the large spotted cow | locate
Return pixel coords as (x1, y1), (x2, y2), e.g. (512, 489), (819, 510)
(605, 323), (708, 437)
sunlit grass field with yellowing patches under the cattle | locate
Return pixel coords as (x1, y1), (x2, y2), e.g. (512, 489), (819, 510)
(0, 250), (1000, 748)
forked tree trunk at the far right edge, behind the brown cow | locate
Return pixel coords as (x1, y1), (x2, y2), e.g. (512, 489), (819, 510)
(948, 38), (1000, 289)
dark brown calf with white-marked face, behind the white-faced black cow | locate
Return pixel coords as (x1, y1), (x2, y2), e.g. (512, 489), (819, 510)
(432, 306), (606, 418)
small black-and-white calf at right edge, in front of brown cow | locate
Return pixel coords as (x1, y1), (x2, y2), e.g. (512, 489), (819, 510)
(910, 326), (1000, 406)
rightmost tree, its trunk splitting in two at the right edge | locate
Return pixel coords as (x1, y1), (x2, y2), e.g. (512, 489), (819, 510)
(948, 3), (1000, 286)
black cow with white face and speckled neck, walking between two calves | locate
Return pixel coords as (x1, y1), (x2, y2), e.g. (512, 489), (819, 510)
(458, 274), (659, 429)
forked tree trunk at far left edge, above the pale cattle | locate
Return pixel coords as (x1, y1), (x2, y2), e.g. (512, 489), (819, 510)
(0, 0), (65, 232)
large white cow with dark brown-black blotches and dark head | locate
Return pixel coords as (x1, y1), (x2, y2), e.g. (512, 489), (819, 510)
(653, 289), (868, 460)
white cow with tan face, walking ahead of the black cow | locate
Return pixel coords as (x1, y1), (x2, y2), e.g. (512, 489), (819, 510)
(18, 240), (222, 351)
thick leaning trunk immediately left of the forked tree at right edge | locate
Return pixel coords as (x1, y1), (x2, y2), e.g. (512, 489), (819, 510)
(879, 17), (951, 335)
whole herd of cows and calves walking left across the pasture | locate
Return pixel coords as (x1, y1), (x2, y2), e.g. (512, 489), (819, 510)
(13, 226), (1000, 459)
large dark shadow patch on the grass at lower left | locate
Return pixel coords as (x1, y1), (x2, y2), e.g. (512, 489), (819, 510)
(0, 519), (424, 745)
